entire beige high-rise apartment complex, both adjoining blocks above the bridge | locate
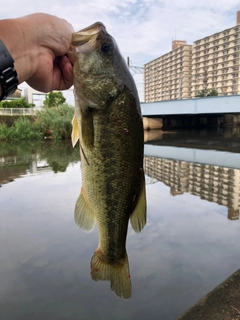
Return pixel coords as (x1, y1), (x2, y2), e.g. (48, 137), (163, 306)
(144, 11), (240, 102)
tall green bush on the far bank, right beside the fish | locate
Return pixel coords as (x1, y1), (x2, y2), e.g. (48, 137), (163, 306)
(36, 104), (74, 139)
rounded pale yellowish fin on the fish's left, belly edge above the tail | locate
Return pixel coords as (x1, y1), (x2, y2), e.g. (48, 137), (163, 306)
(74, 189), (95, 232)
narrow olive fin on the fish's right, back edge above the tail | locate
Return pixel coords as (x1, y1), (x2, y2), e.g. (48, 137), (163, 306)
(130, 174), (147, 232)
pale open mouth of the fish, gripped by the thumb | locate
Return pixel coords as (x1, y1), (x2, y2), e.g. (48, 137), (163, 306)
(72, 22), (106, 47)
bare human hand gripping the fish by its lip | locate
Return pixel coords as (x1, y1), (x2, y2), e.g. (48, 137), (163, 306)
(0, 13), (74, 92)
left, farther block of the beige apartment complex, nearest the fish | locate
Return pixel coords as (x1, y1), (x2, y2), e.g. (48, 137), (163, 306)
(144, 40), (192, 102)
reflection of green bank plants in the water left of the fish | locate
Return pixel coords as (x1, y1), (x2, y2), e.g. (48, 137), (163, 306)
(0, 141), (79, 186)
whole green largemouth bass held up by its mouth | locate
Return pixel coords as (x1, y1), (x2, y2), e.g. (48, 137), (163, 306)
(70, 22), (146, 299)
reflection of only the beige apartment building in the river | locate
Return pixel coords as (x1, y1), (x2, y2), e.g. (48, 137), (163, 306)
(144, 156), (240, 220)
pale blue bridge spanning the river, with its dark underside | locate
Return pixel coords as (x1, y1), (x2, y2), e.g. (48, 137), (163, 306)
(141, 95), (240, 129)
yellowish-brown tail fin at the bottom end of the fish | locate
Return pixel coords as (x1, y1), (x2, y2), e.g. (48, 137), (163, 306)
(91, 249), (131, 299)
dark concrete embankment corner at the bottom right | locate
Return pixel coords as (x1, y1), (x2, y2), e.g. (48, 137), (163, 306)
(177, 269), (240, 320)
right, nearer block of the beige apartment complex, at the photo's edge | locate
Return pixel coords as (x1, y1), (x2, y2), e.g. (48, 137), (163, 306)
(191, 11), (240, 97)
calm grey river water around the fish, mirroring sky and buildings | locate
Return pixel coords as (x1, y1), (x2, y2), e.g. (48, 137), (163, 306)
(0, 131), (240, 320)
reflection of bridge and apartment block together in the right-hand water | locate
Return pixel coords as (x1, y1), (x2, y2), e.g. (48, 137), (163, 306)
(144, 128), (240, 220)
